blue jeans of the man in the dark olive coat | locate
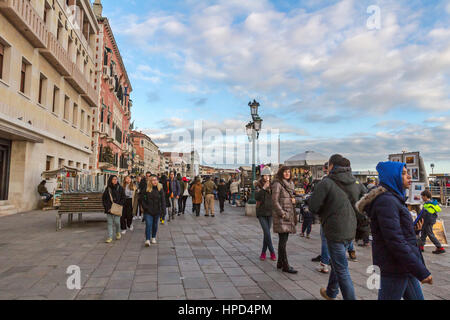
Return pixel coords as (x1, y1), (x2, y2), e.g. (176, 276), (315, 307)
(327, 240), (356, 300)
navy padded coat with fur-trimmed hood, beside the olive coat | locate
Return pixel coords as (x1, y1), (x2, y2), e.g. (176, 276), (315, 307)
(356, 184), (430, 281)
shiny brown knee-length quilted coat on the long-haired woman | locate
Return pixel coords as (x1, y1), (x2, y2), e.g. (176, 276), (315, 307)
(272, 180), (298, 234)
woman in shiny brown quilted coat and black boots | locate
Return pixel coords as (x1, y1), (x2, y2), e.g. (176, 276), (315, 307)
(272, 167), (298, 274)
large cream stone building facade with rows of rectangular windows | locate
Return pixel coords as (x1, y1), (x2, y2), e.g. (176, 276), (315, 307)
(0, 0), (99, 212)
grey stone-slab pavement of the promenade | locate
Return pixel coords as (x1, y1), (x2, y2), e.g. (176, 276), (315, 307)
(0, 200), (450, 300)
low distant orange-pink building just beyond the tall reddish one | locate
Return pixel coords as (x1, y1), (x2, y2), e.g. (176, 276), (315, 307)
(131, 131), (160, 174)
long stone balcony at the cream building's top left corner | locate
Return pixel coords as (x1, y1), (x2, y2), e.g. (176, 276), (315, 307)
(0, 0), (48, 48)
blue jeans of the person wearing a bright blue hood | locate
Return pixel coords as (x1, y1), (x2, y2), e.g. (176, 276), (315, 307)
(378, 275), (425, 300)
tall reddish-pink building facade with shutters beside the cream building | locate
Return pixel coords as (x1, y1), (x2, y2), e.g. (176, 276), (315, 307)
(91, 0), (133, 175)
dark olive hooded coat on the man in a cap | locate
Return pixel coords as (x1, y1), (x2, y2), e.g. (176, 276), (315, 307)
(309, 167), (364, 242)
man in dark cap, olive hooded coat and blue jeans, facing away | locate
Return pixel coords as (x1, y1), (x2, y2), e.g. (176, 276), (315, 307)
(309, 155), (360, 300)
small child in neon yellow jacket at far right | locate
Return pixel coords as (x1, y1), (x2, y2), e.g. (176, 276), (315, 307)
(419, 190), (445, 254)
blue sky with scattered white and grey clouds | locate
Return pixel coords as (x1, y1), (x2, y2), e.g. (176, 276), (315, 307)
(102, 0), (450, 172)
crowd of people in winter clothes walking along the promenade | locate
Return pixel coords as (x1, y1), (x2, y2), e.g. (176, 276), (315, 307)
(103, 155), (445, 300)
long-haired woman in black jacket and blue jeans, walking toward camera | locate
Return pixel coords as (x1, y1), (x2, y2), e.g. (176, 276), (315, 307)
(142, 175), (166, 247)
